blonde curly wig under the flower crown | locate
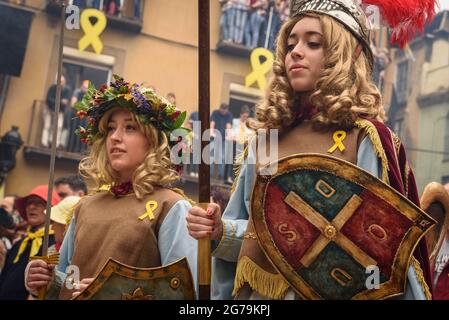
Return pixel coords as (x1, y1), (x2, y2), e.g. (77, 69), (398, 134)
(79, 108), (179, 199)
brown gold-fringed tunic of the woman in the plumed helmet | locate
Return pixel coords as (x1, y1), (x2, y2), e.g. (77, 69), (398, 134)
(234, 121), (365, 299)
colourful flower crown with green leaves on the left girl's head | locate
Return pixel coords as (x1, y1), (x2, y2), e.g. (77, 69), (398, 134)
(75, 74), (189, 145)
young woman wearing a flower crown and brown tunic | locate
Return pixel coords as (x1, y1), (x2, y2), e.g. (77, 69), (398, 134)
(26, 76), (197, 299)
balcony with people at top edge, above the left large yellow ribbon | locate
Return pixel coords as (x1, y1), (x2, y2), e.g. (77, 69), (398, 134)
(45, 0), (144, 33)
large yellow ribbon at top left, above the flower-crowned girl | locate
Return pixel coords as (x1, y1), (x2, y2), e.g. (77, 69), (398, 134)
(78, 9), (107, 54)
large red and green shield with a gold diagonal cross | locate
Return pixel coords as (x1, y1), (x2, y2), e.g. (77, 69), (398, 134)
(251, 154), (435, 299)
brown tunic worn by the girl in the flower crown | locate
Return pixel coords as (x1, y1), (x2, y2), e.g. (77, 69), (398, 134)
(60, 188), (183, 299)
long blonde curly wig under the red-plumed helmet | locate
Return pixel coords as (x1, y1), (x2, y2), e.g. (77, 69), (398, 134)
(248, 13), (382, 133)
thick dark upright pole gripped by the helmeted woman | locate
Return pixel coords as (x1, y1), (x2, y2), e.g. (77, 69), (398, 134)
(198, 0), (211, 300)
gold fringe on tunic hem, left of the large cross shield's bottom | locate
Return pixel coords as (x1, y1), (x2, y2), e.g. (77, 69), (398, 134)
(232, 256), (290, 299)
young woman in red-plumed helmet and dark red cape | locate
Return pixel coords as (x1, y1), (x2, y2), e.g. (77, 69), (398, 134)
(187, 0), (434, 299)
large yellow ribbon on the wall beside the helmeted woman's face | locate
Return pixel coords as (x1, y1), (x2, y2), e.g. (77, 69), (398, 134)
(245, 48), (274, 90)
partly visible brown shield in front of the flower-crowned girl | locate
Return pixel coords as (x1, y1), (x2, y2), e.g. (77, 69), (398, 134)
(74, 258), (195, 300)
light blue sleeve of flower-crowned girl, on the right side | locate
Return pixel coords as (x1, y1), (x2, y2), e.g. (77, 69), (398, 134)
(158, 200), (198, 292)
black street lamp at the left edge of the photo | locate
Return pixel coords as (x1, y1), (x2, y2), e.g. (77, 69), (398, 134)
(0, 126), (23, 185)
